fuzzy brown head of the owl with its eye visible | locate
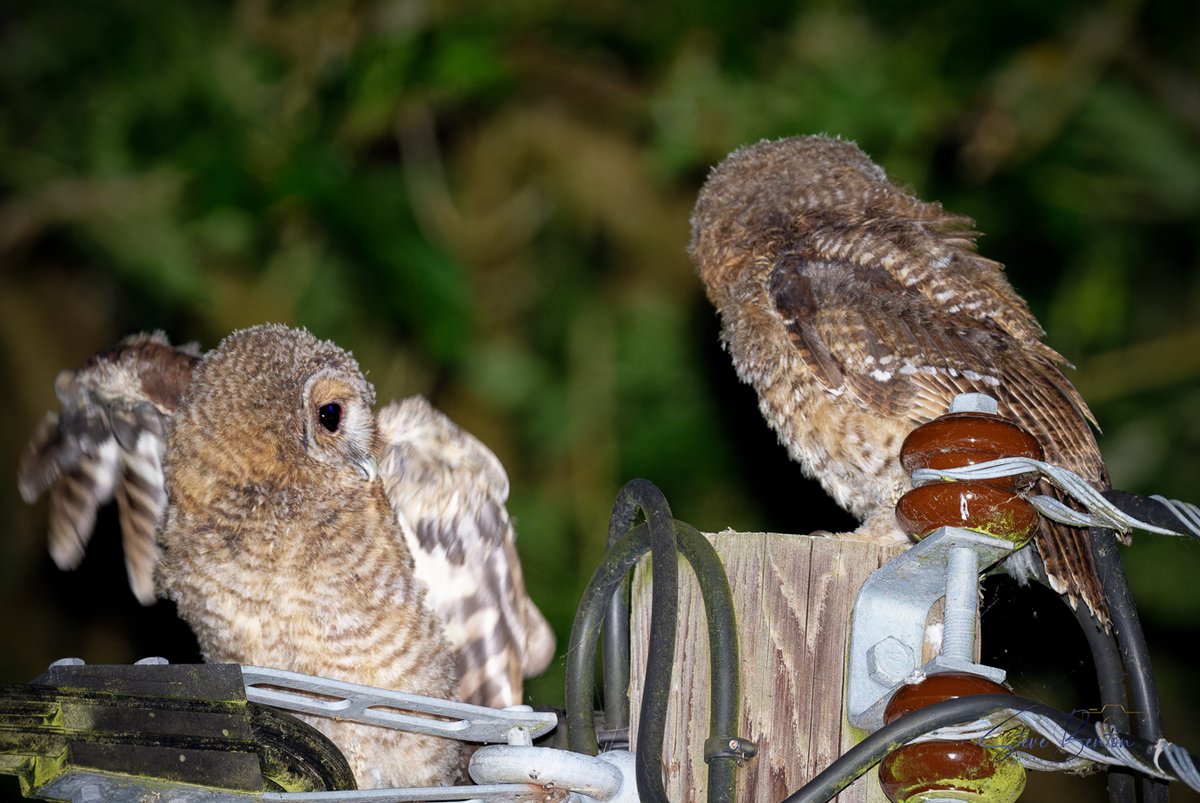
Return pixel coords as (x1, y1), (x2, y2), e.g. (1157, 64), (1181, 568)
(168, 324), (377, 484)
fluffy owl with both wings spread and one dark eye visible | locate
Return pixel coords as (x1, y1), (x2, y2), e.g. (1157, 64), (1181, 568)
(20, 325), (553, 787)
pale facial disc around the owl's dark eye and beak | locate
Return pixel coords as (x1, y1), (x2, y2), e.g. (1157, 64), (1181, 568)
(304, 371), (379, 483)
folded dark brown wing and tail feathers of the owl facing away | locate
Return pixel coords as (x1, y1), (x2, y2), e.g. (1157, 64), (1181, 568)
(769, 254), (1108, 618)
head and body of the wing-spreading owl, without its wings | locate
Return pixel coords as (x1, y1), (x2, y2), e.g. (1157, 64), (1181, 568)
(158, 326), (460, 787)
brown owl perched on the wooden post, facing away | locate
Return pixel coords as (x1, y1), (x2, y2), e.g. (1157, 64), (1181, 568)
(690, 137), (1108, 621)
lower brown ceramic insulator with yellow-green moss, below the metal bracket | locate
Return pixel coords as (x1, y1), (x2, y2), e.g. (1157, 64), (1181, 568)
(880, 672), (1025, 803)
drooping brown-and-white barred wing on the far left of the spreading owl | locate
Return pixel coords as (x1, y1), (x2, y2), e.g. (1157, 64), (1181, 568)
(17, 332), (199, 605)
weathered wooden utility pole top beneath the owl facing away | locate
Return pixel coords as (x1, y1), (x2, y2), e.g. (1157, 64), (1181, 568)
(630, 531), (906, 803)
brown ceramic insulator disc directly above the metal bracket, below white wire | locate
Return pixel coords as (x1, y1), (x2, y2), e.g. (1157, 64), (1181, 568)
(896, 483), (1039, 544)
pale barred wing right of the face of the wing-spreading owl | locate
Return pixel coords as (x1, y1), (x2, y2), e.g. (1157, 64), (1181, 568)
(379, 396), (554, 707)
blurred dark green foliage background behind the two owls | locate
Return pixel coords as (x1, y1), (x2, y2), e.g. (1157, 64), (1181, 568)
(0, 0), (1200, 799)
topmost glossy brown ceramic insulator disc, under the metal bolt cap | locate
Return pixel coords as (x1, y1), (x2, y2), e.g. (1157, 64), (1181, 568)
(900, 413), (1043, 491)
